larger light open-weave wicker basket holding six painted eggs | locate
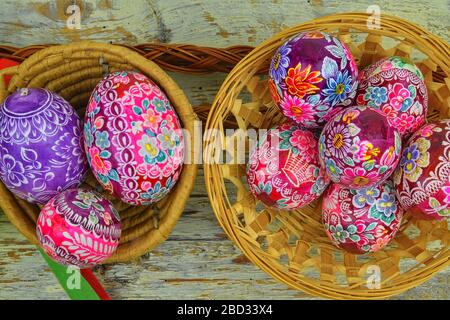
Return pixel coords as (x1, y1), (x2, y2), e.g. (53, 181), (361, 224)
(204, 13), (450, 299)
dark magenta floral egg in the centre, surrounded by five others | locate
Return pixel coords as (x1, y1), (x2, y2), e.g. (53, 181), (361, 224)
(319, 106), (401, 189)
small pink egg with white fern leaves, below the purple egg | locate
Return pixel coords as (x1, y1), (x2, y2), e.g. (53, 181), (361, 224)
(36, 188), (121, 268)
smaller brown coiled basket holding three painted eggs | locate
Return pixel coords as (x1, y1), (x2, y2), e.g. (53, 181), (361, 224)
(0, 42), (197, 263)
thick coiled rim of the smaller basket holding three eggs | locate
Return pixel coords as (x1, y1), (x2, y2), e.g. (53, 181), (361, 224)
(0, 41), (198, 264)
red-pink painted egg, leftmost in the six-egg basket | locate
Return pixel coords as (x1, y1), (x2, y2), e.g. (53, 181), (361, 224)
(247, 123), (329, 210)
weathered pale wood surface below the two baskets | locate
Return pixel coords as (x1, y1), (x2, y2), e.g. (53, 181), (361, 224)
(0, 171), (450, 299)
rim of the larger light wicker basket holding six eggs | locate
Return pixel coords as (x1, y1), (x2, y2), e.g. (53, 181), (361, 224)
(203, 12), (450, 299)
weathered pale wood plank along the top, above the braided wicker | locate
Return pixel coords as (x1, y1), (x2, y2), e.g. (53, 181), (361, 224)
(0, 0), (449, 47)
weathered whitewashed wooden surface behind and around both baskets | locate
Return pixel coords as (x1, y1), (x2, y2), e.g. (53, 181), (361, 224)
(0, 0), (450, 299)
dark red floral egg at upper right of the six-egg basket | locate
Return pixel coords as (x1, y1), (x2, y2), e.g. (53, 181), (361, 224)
(356, 57), (428, 137)
